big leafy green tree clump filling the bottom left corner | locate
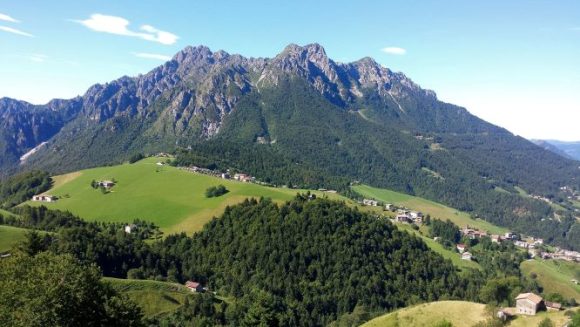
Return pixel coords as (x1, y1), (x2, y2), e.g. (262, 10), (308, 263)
(0, 252), (143, 327)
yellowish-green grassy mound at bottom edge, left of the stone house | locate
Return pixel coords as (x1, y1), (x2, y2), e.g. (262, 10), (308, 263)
(362, 301), (485, 327)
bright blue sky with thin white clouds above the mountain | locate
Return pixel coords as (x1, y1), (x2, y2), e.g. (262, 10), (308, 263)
(0, 0), (580, 140)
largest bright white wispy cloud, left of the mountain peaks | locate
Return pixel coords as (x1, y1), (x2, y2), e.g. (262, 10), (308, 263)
(73, 14), (179, 45)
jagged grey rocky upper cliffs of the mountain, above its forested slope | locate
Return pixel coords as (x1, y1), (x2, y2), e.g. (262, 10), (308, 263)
(0, 44), (498, 174)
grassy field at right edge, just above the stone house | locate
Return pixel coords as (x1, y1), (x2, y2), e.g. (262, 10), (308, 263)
(521, 259), (580, 302)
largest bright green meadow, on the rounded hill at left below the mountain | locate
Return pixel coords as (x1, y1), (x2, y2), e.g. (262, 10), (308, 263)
(27, 158), (338, 233)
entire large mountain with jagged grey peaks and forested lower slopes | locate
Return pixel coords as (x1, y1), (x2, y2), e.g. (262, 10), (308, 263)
(0, 44), (580, 249)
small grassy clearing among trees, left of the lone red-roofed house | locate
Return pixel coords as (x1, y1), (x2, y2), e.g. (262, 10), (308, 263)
(103, 277), (192, 317)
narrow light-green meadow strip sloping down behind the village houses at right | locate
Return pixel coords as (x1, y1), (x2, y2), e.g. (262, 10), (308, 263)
(353, 185), (507, 233)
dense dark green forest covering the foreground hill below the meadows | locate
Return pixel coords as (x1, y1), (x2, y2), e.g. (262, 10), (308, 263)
(0, 194), (560, 326)
